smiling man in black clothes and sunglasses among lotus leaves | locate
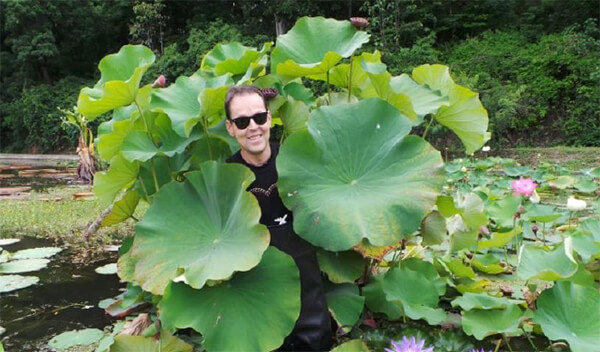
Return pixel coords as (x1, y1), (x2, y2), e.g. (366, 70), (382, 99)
(225, 86), (332, 351)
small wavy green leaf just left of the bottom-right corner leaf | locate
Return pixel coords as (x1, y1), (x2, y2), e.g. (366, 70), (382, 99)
(462, 304), (523, 341)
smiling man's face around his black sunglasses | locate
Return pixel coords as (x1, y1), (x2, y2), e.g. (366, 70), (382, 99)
(226, 93), (271, 161)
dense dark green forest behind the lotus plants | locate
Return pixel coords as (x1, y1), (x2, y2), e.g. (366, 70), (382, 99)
(0, 0), (600, 153)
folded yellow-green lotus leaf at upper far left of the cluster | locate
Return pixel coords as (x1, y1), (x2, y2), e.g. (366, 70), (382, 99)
(77, 45), (155, 119)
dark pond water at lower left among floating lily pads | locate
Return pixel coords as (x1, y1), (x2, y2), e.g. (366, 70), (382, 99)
(0, 237), (123, 352)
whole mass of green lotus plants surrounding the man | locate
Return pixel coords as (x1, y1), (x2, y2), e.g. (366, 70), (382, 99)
(36, 18), (600, 352)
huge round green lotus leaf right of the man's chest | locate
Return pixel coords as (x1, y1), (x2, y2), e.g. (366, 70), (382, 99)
(277, 99), (444, 251)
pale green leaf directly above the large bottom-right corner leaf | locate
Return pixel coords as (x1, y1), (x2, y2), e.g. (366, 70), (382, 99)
(517, 241), (577, 281)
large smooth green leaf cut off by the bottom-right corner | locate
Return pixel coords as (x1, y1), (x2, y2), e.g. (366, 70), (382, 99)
(533, 281), (600, 352)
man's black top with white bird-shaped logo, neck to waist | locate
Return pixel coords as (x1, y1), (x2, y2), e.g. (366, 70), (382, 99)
(227, 143), (292, 227)
